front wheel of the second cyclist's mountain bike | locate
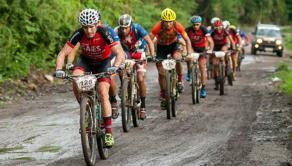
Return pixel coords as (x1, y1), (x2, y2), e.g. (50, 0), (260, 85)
(121, 77), (132, 132)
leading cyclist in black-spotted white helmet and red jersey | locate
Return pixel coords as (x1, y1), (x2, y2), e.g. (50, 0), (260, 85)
(55, 9), (125, 147)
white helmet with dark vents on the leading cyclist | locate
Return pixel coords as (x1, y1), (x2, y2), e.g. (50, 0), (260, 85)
(79, 9), (100, 26)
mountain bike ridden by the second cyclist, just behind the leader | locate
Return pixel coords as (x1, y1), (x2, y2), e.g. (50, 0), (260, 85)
(121, 59), (146, 132)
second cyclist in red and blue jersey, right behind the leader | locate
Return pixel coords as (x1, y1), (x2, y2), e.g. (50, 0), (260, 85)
(115, 14), (154, 120)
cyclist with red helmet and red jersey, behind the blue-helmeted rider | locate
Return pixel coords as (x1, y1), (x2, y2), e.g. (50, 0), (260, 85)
(211, 20), (235, 90)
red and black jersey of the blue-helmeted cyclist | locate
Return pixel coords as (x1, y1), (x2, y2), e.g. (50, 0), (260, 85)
(186, 26), (210, 48)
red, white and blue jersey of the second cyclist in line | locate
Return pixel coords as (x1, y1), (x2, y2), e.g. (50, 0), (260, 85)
(115, 23), (148, 52)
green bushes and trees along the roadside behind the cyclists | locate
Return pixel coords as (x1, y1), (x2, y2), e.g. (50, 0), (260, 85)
(0, 0), (292, 82)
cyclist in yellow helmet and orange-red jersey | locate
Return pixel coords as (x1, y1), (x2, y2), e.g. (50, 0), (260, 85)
(150, 8), (193, 110)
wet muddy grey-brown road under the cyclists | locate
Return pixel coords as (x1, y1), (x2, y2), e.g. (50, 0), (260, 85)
(0, 52), (292, 166)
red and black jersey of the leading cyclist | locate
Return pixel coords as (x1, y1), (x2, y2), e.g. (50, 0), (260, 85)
(67, 25), (119, 62)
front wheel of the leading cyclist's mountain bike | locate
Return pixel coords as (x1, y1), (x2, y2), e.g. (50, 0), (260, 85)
(80, 96), (97, 166)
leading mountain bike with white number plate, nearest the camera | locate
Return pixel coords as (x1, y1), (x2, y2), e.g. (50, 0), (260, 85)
(64, 72), (117, 166)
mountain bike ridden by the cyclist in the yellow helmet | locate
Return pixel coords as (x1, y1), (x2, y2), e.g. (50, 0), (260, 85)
(154, 55), (180, 119)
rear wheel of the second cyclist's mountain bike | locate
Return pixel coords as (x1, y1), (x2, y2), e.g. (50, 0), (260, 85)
(132, 77), (141, 127)
